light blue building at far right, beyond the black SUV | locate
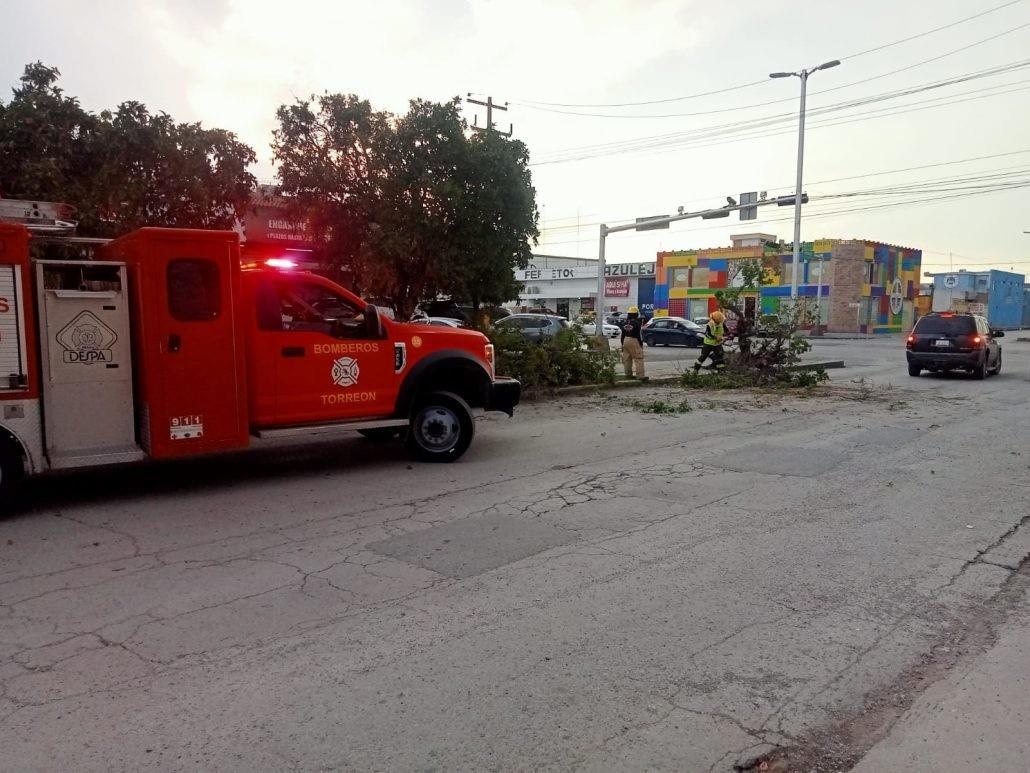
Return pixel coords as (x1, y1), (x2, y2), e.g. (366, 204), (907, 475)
(931, 269), (1026, 330)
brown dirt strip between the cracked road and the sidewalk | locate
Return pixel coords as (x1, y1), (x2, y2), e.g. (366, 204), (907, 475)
(734, 557), (1030, 773)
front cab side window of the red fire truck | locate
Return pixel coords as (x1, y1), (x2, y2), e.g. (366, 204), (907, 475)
(259, 279), (367, 338)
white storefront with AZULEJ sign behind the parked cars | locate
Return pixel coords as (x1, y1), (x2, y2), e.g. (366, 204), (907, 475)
(508, 255), (655, 320)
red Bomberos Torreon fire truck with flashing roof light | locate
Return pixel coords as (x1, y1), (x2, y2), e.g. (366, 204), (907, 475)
(0, 200), (520, 505)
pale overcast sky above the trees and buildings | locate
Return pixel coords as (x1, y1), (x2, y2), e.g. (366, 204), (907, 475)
(6, 0), (1030, 273)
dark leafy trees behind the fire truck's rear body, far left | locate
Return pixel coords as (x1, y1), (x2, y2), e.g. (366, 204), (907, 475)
(0, 62), (255, 236)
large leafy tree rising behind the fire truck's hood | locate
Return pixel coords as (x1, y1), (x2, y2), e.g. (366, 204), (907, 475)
(272, 94), (538, 316)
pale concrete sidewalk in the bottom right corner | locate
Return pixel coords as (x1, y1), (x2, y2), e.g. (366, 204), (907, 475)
(854, 592), (1030, 773)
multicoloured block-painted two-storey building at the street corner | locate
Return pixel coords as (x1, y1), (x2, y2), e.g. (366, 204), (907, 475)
(655, 234), (922, 333)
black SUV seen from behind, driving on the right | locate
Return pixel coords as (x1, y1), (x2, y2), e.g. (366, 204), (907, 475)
(905, 311), (1004, 378)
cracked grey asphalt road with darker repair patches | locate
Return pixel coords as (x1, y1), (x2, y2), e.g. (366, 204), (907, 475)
(0, 340), (1030, 771)
